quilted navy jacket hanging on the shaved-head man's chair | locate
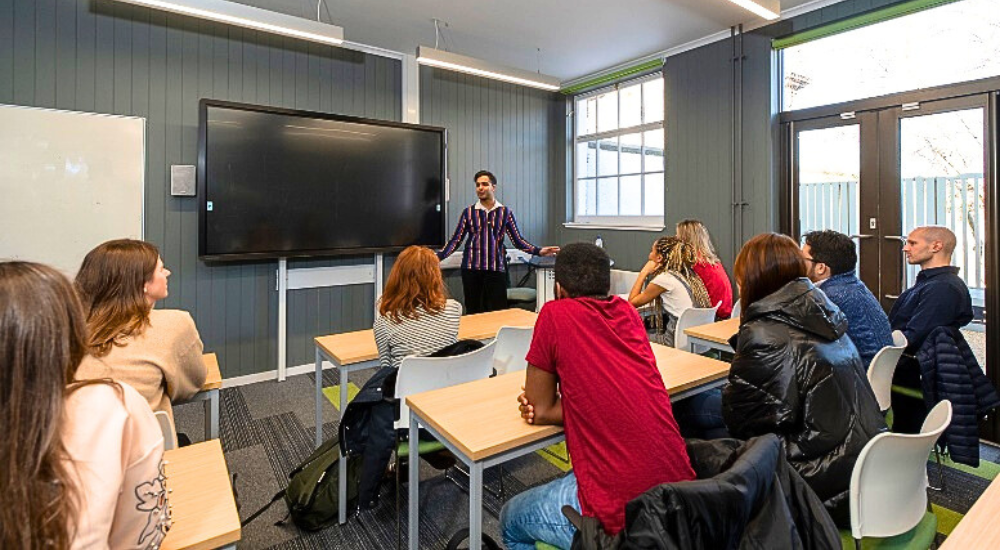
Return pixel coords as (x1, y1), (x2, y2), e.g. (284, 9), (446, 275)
(917, 327), (1000, 467)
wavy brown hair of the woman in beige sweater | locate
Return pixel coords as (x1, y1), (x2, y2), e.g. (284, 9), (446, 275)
(76, 239), (160, 357)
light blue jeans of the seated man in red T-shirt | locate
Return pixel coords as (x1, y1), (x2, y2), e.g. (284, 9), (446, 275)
(500, 472), (580, 550)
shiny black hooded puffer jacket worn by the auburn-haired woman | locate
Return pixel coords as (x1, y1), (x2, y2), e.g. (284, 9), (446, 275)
(722, 278), (885, 526)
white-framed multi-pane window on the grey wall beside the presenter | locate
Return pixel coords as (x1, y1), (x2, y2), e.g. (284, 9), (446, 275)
(573, 73), (665, 226)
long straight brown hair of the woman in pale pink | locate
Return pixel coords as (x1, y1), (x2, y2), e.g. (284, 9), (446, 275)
(0, 262), (108, 549)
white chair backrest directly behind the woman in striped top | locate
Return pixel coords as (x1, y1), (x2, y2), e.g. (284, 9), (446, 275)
(396, 340), (496, 429)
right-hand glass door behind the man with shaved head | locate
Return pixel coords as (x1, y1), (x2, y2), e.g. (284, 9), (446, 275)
(879, 96), (989, 368)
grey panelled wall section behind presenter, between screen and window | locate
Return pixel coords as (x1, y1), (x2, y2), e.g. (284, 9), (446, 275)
(420, 67), (564, 301)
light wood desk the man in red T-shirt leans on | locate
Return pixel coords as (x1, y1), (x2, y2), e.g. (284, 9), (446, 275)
(406, 344), (729, 550)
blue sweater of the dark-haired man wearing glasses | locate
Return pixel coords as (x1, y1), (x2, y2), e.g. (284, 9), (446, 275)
(820, 271), (892, 370)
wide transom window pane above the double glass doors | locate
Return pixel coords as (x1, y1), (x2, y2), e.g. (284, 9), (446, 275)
(782, 0), (1000, 111)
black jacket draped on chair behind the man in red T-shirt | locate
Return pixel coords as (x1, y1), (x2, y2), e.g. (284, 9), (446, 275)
(573, 434), (841, 550)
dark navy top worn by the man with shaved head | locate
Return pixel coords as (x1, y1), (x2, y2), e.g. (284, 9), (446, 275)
(889, 266), (973, 354)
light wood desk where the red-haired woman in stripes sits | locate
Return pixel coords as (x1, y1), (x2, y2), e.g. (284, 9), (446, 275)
(315, 308), (538, 524)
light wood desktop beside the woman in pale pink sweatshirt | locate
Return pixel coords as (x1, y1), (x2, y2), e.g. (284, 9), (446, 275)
(161, 439), (241, 550)
